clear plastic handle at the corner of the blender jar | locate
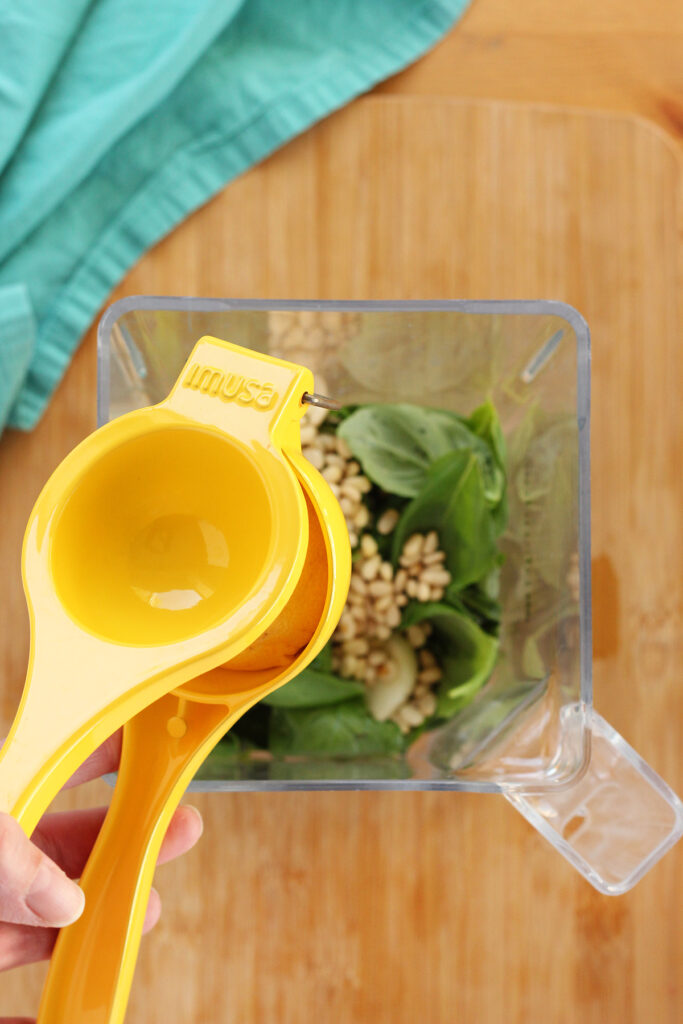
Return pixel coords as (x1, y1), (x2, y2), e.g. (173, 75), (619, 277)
(504, 709), (683, 896)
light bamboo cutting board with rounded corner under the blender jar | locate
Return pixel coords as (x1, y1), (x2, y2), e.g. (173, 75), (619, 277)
(0, 96), (683, 1024)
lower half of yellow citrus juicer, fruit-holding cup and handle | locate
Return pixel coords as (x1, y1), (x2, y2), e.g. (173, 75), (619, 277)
(38, 454), (351, 1024)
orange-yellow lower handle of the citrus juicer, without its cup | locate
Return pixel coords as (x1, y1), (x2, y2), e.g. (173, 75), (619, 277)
(38, 694), (229, 1024)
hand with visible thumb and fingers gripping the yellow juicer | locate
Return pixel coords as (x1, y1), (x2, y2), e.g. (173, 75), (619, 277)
(0, 732), (202, 1011)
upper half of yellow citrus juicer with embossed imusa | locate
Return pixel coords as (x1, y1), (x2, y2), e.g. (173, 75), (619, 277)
(0, 338), (323, 835)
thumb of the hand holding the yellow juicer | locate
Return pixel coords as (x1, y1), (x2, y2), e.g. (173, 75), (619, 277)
(0, 814), (85, 928)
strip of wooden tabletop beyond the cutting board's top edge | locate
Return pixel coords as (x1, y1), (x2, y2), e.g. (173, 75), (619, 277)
(378, 0), (683, 143)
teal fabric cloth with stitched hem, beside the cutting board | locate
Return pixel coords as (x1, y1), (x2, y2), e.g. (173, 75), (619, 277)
(0, 0), (467, 430)
